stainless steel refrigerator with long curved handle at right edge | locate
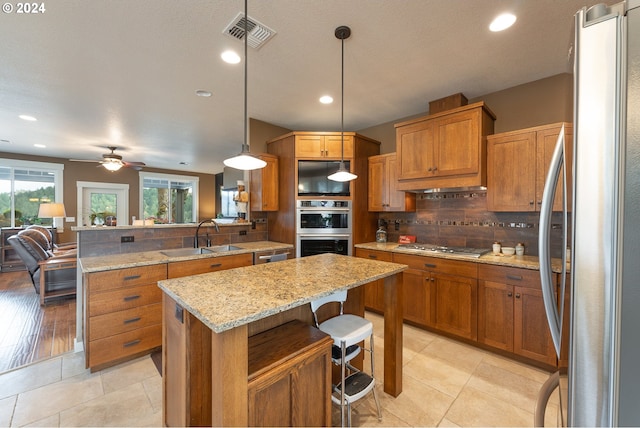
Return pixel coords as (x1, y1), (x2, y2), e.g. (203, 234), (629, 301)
(539, 0), (640, 426)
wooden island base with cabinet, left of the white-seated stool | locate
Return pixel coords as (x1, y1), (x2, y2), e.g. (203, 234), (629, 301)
(162, 294), (333, 426)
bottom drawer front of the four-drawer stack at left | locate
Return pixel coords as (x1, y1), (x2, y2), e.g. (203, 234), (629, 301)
(89, 324), (162, 367)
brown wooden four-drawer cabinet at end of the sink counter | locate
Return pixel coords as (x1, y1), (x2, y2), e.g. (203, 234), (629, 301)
(84, 264), (167, 371)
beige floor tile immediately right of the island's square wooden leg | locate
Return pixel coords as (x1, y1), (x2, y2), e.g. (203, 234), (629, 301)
(403, 354), (472, 397)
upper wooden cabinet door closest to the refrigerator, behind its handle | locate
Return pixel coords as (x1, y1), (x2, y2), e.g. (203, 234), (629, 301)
(536, 124), (573, 211)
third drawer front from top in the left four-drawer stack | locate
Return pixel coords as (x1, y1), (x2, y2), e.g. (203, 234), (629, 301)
(89, 303), (162, 341)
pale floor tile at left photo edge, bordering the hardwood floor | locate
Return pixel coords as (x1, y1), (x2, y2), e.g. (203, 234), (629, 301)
(0, 357), (62, 398)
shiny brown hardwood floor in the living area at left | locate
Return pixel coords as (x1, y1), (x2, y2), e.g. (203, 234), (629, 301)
(0, 271), (76, 373)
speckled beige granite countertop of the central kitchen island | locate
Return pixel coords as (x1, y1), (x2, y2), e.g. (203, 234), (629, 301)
(158, 253), (407, 333)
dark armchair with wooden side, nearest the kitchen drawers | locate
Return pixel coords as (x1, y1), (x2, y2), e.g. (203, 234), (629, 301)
(7, 230), (77, 305)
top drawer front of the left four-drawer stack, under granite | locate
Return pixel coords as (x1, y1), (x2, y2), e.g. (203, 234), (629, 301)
(87, 263), (167, 293)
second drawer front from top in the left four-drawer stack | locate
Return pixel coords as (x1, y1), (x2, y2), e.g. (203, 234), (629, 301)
(88, 284), (162, 317)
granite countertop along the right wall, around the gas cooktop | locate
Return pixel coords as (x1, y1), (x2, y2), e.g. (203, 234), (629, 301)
(355, 242), (569, 273)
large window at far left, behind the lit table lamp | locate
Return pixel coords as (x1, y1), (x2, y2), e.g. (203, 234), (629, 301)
(0, 159), (64, 228)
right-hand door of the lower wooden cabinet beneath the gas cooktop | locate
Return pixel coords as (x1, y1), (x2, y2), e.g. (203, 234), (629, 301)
(431, 273), (478, 340)
